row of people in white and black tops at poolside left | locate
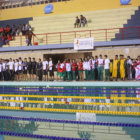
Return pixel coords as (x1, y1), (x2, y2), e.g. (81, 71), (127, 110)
(0, 57), (54, 81)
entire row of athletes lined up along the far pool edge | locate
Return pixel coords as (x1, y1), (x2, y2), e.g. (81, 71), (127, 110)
(0, 55), (140, 81)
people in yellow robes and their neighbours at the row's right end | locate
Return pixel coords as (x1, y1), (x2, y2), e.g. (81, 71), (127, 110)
(111, 55), (140, 81)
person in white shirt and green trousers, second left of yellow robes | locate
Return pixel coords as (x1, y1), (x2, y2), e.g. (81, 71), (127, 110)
(97, 55), (104, 81)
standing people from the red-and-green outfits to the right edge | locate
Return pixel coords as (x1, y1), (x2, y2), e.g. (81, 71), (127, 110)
(56, 55), (140, 81)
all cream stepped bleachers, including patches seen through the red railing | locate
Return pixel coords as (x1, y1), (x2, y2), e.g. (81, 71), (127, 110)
(2, 7), (138, 47)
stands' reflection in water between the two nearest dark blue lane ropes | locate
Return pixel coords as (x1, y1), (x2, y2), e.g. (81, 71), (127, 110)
(0, 119), (140, 140)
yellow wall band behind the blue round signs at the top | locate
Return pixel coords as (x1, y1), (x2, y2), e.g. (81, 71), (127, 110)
(0, 0), (140, 20)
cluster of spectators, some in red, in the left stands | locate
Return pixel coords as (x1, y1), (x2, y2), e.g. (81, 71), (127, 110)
(0, 24), (32, 45)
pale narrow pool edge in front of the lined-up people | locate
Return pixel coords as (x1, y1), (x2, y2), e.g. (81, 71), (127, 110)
(0, 81), (140, 87)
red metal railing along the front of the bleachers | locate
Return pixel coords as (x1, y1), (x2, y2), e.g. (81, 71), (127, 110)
(1, 26), (140, 46)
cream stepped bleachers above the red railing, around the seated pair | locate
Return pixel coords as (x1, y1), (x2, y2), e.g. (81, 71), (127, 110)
(30, 7), (138, 34)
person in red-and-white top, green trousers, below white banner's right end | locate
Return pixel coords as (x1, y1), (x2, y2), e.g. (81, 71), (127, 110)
(89, 56), (95, 80)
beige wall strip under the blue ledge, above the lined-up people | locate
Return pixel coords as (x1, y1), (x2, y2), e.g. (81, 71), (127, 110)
(0, 45), (140, 60)
